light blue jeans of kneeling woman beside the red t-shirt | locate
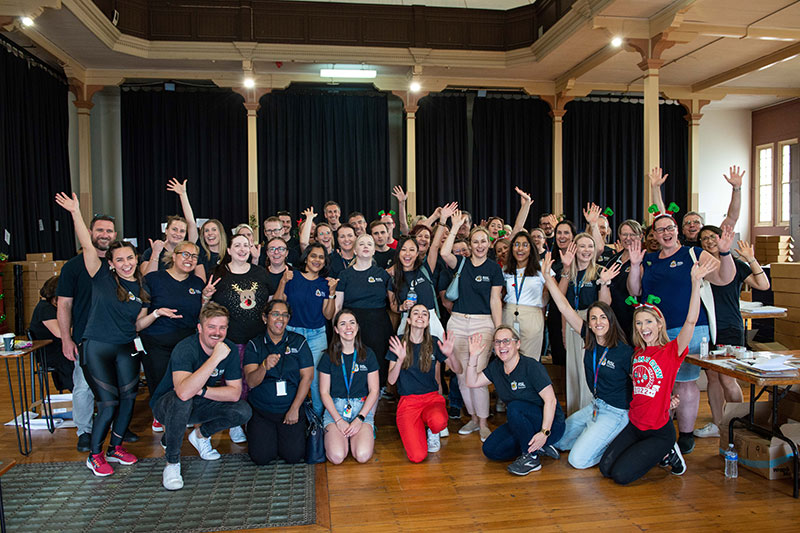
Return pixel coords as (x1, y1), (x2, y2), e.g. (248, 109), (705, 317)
(554, 398), (628, 470)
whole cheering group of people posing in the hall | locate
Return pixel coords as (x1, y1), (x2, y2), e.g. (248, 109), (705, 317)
(32, 163), (769, 490)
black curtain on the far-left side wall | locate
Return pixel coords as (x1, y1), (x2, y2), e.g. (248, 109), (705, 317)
(0, 37), (75, 260)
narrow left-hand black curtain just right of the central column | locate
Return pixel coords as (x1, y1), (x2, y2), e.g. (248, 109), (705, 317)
(416, 93), (472, 214)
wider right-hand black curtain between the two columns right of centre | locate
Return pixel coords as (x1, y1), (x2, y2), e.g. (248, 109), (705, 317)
(472, 96), (553, 226)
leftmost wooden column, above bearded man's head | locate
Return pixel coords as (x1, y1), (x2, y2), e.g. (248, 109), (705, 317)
(69, 78), (103, 224)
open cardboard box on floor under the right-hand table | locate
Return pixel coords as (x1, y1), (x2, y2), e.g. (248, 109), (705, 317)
(719, 402), (800, 479)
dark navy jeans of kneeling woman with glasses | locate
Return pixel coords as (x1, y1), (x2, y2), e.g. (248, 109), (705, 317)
(483, 400), (564, 461)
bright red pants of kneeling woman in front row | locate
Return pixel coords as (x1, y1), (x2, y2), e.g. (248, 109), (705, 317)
(397, 392), (447, 463)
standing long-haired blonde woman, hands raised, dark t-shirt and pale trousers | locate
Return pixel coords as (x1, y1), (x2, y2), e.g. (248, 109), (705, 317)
(558, 233), (619, 416)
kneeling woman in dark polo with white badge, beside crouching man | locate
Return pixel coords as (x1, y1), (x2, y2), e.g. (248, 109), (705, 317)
(244, 300), (314, 465)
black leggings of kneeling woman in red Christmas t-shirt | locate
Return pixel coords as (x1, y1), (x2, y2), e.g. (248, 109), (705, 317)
(600, 419), (675, 485)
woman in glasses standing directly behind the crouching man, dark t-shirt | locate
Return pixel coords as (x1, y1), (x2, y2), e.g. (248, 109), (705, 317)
(140, 241), (210, 432)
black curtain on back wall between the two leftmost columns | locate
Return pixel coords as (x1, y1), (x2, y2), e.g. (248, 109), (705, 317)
(120, 86), (248, 245)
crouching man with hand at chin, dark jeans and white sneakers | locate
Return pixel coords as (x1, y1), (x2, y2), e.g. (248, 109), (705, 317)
(150, 302), (252, 490)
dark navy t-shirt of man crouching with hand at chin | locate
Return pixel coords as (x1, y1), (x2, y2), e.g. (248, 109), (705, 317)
(145, 334), (242, 407)
